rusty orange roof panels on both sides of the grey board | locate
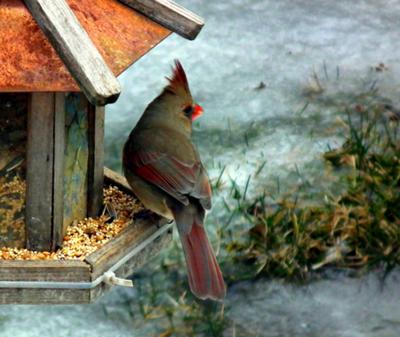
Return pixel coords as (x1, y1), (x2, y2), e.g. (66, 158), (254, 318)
(0, 0), (171, 92)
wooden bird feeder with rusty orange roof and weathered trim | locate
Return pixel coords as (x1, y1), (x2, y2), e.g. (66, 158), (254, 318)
(0, 0), (203, 304)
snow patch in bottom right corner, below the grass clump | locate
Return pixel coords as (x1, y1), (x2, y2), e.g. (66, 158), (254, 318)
(229, 272), (400, 337)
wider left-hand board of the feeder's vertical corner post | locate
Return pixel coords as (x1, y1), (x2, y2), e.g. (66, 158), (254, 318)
(25, 93), (54, 250)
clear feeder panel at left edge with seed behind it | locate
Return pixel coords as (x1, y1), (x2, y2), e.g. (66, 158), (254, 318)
(0, 93), (28, 247)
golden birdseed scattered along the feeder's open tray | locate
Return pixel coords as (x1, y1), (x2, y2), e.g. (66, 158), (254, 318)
(0, 186), (142, 260)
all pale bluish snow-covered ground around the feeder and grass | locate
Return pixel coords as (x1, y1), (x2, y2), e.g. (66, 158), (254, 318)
(0, 0), (400, 337)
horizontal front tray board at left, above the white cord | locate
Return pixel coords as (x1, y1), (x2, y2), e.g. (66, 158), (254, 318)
(0, 260), (90, 282)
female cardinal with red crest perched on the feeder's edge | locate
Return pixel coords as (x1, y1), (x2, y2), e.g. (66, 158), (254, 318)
(123, 61), (225, 300)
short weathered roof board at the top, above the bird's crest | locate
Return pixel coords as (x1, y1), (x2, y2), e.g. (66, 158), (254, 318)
(119, 0), (204, 40)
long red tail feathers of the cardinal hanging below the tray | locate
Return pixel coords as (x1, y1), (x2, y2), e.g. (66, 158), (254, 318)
(180, 224), (226, 300)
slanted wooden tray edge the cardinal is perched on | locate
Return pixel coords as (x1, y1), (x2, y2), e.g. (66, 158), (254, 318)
(85, 219), (167, 280)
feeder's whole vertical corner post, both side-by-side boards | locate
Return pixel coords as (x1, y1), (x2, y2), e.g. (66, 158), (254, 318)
(25, 93), (65, 251)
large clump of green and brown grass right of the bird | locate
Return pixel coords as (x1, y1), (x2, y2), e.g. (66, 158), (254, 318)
(226, 105), (400, 281)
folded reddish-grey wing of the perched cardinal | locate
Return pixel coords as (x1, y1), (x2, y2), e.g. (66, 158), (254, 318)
(130, 151), (211, 209)
